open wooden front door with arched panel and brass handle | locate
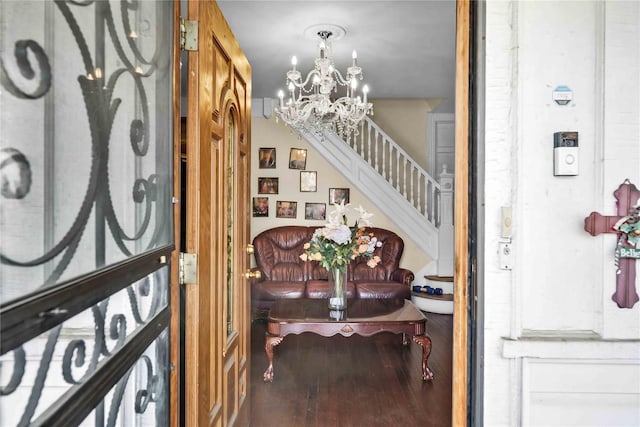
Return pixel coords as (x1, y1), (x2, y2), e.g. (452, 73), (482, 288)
(185, 0), (251, 427)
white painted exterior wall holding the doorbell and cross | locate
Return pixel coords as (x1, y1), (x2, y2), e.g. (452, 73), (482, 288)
(483, 1), (640, 426)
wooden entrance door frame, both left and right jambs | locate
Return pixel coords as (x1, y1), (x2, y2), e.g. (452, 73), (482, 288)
(170, 0), (473, 426)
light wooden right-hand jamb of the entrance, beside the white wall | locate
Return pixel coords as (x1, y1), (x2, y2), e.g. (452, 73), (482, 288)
(451, 0), (471, 426)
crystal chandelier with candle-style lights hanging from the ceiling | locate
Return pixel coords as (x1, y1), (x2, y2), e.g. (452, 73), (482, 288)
(275, 30), (373, 140)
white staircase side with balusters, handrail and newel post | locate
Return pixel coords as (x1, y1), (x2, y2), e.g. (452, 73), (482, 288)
(300, 117), (453, 276)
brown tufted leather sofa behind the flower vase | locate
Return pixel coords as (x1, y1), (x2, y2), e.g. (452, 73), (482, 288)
(250, 226), (414, 316)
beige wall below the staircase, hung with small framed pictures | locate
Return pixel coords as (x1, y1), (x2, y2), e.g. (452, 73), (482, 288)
(251, 117), (430, 279)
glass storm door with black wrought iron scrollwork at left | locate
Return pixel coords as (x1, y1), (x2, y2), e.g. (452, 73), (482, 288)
(0, 0), (174, 426)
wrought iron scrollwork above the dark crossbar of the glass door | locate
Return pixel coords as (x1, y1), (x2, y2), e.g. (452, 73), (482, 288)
(0, 0), (170, 287)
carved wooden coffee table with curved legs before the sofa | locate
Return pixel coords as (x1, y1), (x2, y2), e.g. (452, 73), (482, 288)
(264, 299), (433, 381)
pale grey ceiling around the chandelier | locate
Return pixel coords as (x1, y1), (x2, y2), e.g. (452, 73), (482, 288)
(218, 0), (456, 112)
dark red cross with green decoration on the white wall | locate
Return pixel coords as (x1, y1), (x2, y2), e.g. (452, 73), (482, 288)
(584, 180), (640, 308)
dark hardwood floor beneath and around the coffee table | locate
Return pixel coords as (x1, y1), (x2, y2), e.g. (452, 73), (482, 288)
(250, 313), (453, 427)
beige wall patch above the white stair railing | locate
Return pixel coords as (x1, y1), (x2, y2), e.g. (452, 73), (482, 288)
(371, 99), (441, 170)
